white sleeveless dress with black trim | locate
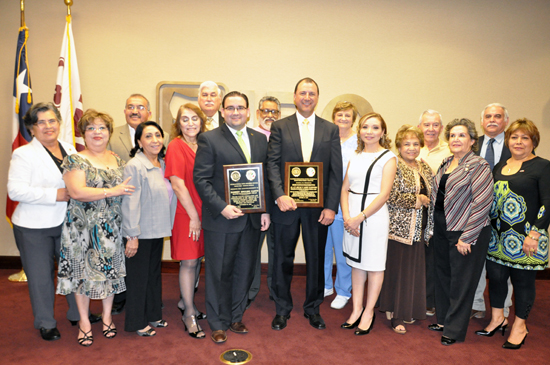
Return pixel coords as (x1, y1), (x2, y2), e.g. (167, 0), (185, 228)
(343, 150), (397, 271)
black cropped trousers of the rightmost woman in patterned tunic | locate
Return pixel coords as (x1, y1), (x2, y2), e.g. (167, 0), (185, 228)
(487, 260), (537, 319)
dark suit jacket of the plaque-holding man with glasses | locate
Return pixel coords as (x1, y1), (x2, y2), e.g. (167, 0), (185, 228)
(193, 123), (273, 233)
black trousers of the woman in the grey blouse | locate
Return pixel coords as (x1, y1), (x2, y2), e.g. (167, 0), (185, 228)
(124, 238), (164, 332)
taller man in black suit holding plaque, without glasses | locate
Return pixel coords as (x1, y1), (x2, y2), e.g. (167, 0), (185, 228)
(267, 78), (342, 330)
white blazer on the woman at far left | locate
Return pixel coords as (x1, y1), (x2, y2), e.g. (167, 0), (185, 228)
(8, 138), (76, 228)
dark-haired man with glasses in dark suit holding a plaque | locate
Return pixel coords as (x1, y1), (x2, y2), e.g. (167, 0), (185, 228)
(193, 91), (272, 343)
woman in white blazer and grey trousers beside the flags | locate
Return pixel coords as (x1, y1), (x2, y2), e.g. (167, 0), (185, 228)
(8, 103), (80, 341)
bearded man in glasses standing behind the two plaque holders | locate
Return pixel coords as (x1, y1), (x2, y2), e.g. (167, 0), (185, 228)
(248, 96), (281, 306)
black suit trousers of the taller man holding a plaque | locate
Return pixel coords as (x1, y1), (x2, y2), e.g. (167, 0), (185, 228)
(271, 208), (328, 315)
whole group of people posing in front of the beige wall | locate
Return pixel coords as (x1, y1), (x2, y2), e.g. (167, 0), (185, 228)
(8, 78), (550, 349)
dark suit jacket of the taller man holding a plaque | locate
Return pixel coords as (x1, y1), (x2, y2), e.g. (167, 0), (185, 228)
(267, 114), (342, 224)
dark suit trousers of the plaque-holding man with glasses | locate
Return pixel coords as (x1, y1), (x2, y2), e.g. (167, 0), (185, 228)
(204, 218), (260, 331)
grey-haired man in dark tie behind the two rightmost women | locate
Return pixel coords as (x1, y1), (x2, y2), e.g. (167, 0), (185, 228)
(470, 103), (512, 318)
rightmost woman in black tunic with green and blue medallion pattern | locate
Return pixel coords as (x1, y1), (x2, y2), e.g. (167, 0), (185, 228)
(476, 119), (550, 349)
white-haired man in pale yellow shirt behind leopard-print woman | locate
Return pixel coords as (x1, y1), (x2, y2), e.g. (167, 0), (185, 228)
(418, 109), (451, 316)
